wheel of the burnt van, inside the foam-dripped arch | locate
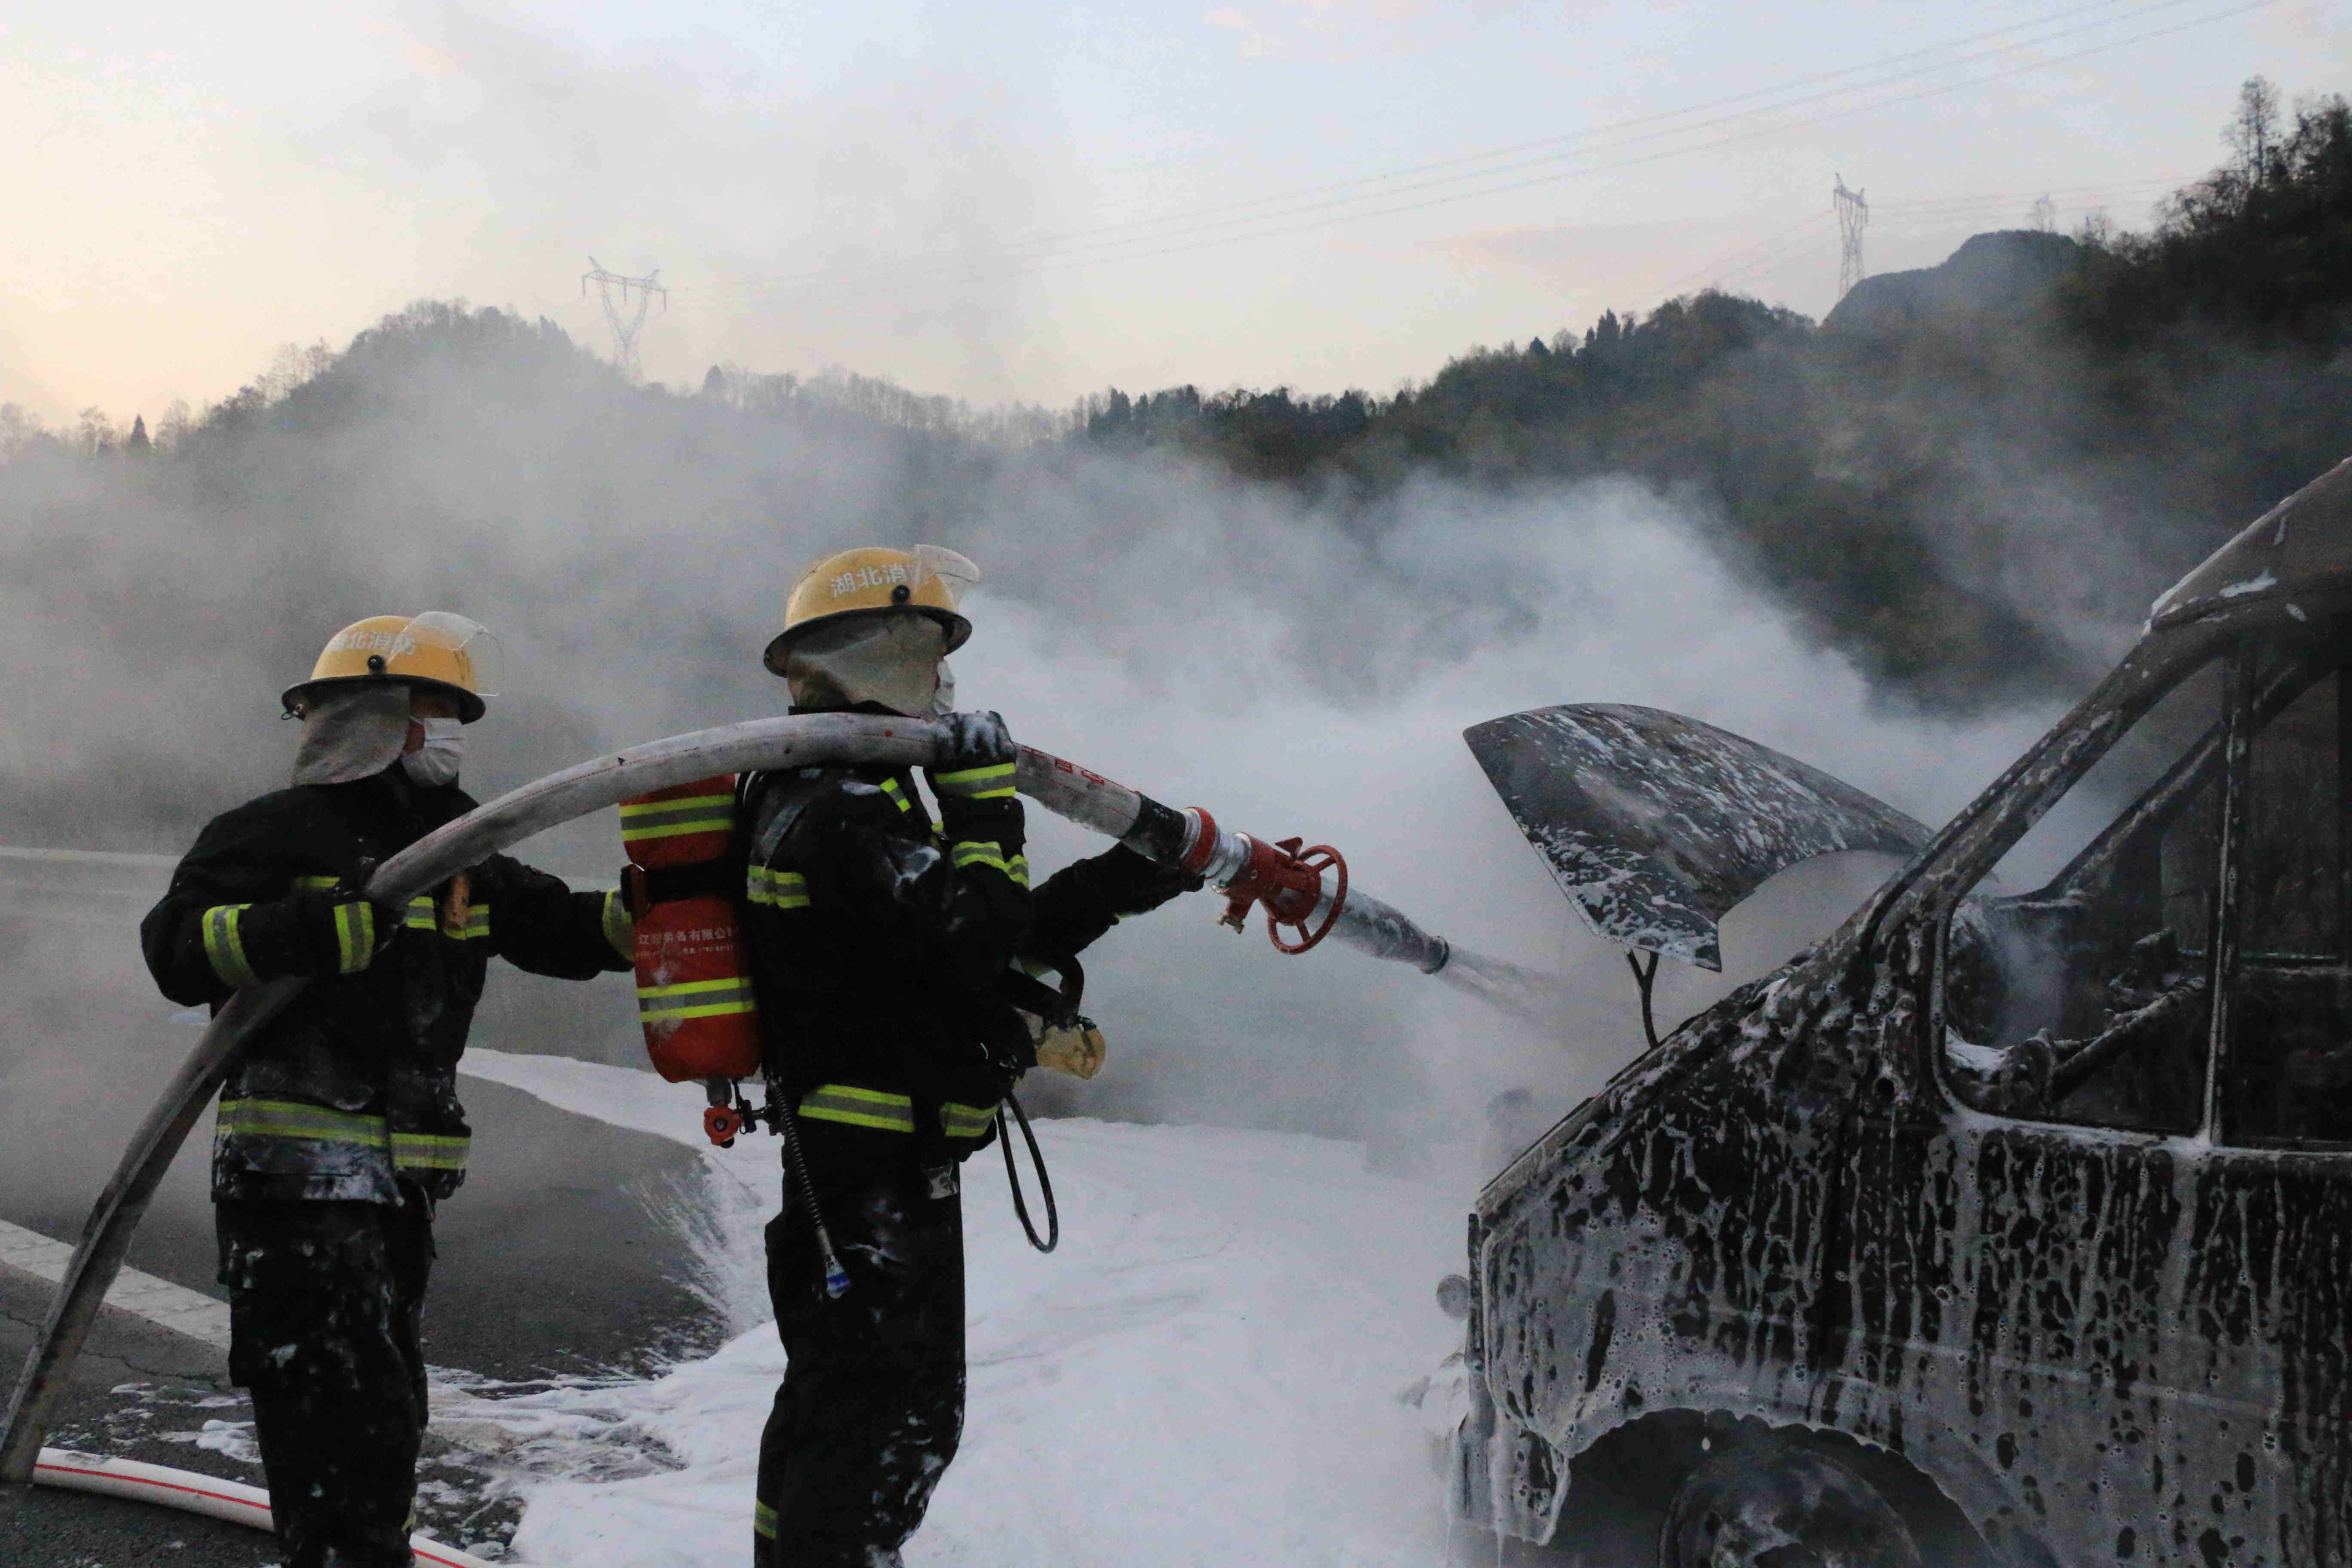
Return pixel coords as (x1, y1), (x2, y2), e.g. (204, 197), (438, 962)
(1658, 1436), (1919, 1568)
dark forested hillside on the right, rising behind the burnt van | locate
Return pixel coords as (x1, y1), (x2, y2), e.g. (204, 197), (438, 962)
(1084, 82), (2352, 707)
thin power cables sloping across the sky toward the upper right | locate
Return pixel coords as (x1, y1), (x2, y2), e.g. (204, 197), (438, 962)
(680, 0), (2277, 310)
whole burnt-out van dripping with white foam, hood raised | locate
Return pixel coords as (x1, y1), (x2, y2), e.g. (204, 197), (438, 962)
(1446, 451), (2352, 1568)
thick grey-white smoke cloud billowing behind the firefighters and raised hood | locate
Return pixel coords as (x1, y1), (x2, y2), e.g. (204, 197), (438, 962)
(0, 308), (2079, 1189)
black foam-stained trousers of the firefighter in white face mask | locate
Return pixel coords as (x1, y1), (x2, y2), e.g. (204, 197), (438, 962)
(214, 1192), (433, 1568)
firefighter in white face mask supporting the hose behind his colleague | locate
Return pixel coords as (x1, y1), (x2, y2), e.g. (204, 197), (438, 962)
(139, 613), (630, 1568)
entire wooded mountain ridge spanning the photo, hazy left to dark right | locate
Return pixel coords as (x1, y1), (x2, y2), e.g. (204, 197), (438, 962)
(0, 82), (2352, 729)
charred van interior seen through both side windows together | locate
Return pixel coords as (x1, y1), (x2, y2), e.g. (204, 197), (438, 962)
(1945, 632), (2352, 1149)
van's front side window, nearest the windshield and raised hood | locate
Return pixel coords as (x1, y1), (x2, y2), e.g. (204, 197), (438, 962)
(1943, 665), (2225, 1133)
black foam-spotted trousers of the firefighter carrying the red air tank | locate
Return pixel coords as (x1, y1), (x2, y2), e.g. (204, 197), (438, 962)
(753, 1121), (965, 1568)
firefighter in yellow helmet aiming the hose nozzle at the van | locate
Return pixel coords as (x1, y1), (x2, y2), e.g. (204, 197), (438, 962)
(736, 545), (1200, 1568)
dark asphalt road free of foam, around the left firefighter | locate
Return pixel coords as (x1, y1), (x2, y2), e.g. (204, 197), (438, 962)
(0, 853), (720, 1568)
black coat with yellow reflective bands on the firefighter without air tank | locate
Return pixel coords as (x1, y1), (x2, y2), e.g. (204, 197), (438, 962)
(139, 762), (630, 1204)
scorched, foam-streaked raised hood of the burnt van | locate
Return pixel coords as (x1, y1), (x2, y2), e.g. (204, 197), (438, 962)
(1463, 703), (1929, 968)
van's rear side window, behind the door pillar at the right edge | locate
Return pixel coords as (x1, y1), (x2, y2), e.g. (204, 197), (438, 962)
(2220, 665), (2352, 1147)
